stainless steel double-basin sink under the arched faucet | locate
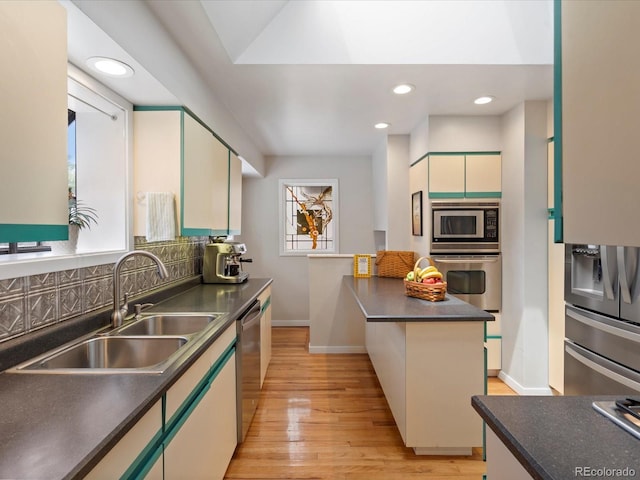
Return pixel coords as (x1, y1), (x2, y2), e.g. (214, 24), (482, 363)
(9, 313), (226, 374)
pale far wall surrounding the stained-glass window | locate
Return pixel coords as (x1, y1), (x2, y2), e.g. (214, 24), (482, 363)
(236, 157), (375, 325)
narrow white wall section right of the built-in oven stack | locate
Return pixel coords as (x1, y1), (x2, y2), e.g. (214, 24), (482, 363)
(500, 102), (550, 394)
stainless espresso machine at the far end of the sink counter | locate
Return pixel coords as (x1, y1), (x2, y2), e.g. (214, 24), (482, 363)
(202, 242), (252, 283)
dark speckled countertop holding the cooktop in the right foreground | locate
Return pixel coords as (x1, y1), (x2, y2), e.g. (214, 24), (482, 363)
(471, 396), (640, 480)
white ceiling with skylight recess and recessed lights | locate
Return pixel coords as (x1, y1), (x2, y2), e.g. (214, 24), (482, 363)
(62, 0), (553, 169)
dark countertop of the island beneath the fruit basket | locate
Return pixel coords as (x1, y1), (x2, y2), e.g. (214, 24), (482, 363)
(342, 275), (495, 322)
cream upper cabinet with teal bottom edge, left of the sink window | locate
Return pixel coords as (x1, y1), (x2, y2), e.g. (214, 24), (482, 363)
(0, 2), (69, 242)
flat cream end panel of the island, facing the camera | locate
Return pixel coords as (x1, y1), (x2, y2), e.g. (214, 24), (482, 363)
(406, 322), (484, 455)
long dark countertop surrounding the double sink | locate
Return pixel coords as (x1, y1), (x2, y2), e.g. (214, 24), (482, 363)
(0, 279), (271, 480)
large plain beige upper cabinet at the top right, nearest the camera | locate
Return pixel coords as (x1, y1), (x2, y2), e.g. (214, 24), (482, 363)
(554, 1), (640, 246)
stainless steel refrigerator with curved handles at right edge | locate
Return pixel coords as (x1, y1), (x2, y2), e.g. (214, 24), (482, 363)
(564, 244), (640, 395)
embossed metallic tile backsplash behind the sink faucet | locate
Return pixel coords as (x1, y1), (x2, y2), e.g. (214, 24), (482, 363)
(0, 237), (208, 342)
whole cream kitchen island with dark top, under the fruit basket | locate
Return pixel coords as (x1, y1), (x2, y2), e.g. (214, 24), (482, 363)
(343, 275), (494, 455)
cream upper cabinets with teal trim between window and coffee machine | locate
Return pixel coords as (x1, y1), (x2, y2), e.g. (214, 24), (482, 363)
(134, 107), (242, 236)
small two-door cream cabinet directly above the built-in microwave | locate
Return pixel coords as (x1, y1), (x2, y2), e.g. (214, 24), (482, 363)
(428, 152), (502, 198)
